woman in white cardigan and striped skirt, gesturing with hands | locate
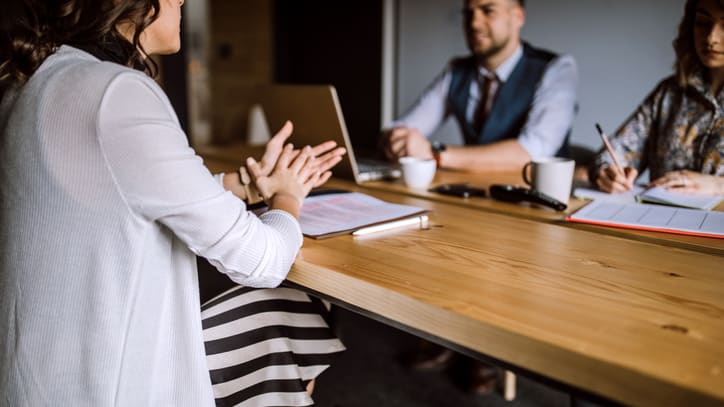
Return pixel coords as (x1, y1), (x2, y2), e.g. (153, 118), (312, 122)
(0, 0), (344, 407)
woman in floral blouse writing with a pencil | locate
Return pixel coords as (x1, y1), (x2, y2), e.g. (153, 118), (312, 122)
(589, 0), (724, 194)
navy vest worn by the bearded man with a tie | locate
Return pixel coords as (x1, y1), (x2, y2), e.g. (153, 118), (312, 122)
(447, 43), (570, 155)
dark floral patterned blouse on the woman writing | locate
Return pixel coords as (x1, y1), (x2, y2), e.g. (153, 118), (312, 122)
(589, 74), (724, 180)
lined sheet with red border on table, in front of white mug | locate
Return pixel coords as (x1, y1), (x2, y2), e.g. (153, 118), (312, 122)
(566, 200), (724, 238)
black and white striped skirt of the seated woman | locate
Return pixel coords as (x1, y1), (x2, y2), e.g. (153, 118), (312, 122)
(201, 287), (345, 407)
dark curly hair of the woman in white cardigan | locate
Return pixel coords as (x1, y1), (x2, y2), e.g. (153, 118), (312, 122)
(0, 0), (160, 84)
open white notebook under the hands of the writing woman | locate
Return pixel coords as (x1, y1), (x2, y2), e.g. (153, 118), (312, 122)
(573, 185), (724, 210)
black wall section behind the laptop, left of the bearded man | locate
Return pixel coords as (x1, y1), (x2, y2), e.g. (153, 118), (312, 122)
(273, 0), (382, 155)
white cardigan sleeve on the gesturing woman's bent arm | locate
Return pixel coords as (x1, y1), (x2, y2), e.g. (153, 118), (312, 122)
(97, 72), (302, 287)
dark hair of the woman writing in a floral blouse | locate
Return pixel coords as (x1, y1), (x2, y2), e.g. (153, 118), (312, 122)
(672, 0), (724, 87)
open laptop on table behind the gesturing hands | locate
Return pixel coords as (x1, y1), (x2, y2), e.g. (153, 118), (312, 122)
(257, 85), (400, 183)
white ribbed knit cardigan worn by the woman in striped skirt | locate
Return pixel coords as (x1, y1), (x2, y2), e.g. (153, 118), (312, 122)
(0, 46), (302, 407)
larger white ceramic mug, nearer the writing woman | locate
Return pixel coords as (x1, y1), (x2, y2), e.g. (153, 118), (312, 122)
(523, 157), (576, 203)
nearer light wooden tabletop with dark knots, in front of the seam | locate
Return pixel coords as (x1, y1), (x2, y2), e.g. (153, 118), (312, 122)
(197, 145), (724, 406)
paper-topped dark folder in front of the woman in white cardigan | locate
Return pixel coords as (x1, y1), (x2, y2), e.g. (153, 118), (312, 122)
(299, 192), (428, 239)
